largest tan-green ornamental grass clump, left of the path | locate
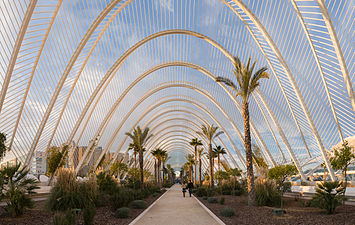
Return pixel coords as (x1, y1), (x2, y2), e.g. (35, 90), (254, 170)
(46, 169), (98, 211)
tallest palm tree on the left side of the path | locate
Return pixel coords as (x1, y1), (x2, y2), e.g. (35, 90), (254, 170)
(126, 126), (152, 189)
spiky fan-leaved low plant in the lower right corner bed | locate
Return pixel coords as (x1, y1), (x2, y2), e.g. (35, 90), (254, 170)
(311, 181), (345, 214)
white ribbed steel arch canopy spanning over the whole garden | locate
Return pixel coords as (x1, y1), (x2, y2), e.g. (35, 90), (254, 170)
(0, 0), (355, 179)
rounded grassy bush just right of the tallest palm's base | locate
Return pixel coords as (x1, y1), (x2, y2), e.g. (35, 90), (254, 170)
(255, 180), (281, 206)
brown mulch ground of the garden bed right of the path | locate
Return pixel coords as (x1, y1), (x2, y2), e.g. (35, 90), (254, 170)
(198, 195), (355, 225)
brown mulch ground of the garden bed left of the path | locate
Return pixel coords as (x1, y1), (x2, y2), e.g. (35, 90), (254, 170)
(0, 193), (163, 225)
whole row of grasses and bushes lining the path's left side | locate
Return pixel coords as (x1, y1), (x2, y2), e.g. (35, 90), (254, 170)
(46, 169), (161, 225)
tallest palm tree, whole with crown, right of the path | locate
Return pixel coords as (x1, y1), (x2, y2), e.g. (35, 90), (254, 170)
(216, 57), (269, 205)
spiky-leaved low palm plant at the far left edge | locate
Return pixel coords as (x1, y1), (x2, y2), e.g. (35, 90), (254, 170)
(0, 163), (39, 216)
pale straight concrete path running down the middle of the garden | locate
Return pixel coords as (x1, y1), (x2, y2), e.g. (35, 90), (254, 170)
(131, 185), (220, 225)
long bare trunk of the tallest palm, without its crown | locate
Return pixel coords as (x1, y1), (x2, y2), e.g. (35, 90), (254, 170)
(243, 100), (256, 205)
